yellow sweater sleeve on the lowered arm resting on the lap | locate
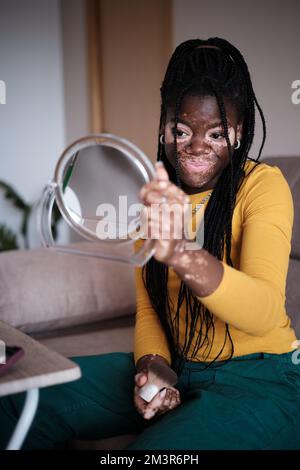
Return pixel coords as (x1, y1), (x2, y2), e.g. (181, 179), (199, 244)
(134, 258), (171, 365)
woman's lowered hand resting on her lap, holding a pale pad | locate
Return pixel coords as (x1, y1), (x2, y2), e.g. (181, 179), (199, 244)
(134, 365), (181, 419)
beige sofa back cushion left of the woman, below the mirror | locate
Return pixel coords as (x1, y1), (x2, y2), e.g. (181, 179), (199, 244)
(0, 244), (136, 333)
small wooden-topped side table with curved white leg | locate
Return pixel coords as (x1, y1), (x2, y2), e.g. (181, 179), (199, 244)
(0, 321), (81, 450)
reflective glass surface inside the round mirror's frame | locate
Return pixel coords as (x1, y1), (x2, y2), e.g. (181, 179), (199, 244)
(62, 146), (145, 240)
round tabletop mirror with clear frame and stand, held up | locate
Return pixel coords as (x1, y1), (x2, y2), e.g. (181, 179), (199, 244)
(39, 134), (155, 265)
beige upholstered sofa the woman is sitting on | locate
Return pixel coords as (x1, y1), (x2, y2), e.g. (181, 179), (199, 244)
(0, 157), (300, 450)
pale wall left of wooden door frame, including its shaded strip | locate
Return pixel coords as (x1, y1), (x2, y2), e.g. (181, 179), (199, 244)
(0, 0), (88, 246)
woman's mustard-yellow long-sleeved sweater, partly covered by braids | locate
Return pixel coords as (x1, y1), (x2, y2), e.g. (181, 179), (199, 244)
(134, 160), (296, 364)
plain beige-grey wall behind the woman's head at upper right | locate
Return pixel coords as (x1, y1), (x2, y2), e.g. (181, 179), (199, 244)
(173, 0), (300, 157)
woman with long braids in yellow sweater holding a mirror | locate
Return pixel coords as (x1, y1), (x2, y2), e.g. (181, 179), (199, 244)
(1, 38), (300, 450)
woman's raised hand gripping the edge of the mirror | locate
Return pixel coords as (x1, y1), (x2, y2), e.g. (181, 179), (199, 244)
(139, 164), (190, 264)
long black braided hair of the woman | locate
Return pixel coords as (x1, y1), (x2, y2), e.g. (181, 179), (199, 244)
(142, 37), (266, 374)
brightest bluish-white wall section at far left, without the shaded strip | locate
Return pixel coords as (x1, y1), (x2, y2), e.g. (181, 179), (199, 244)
(0, 0), (65, 248)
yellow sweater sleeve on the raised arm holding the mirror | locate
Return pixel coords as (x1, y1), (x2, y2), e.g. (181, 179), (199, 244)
(198, 165), (294, 336)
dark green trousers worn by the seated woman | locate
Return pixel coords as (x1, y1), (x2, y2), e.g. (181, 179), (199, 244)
(0, 351), (300, 450)
